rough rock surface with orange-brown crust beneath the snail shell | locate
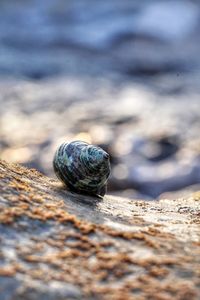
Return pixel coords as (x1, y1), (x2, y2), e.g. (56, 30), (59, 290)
(0, 161), (200, 300)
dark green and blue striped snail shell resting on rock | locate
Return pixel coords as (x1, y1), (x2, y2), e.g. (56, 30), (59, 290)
(53, 141), (110, 196)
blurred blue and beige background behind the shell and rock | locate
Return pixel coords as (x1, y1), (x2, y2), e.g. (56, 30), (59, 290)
(0, 0), (200, 199)
